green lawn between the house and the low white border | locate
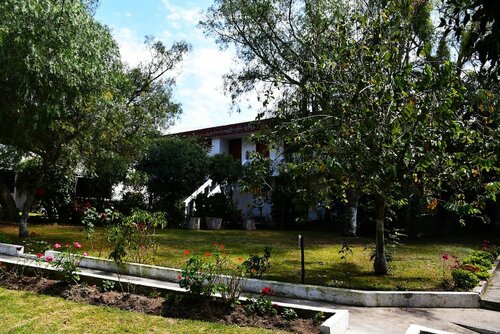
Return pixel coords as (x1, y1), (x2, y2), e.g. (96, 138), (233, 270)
(0, 225), (498, 290)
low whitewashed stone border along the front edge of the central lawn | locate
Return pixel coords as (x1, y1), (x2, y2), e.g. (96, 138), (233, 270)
(0, 245), (500, 308)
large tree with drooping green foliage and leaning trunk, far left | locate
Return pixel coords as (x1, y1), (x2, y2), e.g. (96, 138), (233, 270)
(0, 0), (189, 236)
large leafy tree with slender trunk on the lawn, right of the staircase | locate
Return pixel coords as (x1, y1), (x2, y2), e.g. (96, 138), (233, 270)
(203, 0), (490, 274)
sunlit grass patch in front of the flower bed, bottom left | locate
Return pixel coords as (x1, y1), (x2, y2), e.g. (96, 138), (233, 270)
(0, 288), (277, 334)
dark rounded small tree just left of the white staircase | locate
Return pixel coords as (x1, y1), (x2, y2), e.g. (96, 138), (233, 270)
(136, 136), (208, 218)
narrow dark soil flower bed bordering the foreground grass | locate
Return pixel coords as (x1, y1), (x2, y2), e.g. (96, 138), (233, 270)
(0, 273), (320, 334)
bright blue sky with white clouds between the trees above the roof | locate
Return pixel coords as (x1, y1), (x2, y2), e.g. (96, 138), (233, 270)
(96, 0), (256, 133)
